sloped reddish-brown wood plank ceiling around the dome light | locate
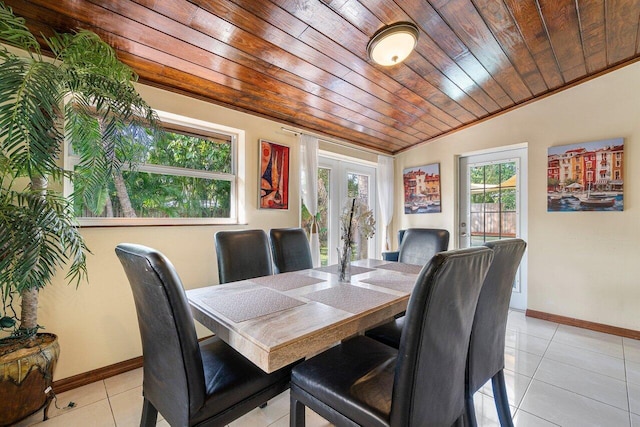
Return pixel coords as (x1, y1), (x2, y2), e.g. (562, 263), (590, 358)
(5, 0), (640, 153)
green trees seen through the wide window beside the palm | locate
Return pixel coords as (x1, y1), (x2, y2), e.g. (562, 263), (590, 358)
(68, 120), (235, 218)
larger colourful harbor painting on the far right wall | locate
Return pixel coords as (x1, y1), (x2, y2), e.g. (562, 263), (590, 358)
(547, 138), (624, 212)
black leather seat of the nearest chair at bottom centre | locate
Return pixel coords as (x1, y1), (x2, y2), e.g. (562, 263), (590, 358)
(291, 336), (398, 426)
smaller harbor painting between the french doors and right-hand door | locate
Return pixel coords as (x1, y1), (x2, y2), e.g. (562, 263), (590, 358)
(402, 163), (441, 214)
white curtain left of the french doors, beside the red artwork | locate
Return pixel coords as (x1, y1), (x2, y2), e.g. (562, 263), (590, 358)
(300, 134), (320, 267)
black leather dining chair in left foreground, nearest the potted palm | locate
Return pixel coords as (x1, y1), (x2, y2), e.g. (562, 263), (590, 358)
(116, 244), (291, 427)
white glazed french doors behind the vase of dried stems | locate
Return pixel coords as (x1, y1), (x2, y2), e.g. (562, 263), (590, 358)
(318, 156), (377, 265)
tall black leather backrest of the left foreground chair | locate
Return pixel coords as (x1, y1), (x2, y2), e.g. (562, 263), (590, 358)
(116, 244), (206, 426)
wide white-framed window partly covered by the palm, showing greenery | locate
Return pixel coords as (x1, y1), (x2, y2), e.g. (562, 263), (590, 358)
(65, 112), (244, 225)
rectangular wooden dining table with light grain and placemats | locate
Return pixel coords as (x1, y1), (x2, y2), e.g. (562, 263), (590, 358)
(186, 259), (422, 372)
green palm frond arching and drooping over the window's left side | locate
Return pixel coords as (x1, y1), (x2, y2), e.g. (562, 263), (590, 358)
(57, 31), (158, 214)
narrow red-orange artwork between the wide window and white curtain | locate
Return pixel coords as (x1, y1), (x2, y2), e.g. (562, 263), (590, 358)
(259, 139), (289, 209)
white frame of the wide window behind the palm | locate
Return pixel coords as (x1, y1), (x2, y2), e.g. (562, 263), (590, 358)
(64, 111), (246, 227)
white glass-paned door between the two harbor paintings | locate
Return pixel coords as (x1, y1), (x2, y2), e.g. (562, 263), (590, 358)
(458, 148), (527, 310)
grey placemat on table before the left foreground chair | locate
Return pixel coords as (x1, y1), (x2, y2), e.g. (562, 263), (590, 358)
(202, 288), (304, 323)
